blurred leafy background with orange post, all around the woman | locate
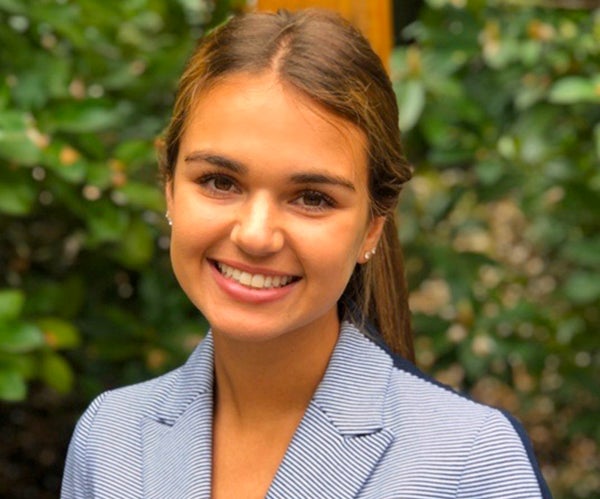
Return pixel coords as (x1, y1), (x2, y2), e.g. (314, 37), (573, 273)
(0, 0), (600, 498)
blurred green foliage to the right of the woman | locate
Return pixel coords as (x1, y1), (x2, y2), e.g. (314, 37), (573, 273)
(393, 0), (600, 497)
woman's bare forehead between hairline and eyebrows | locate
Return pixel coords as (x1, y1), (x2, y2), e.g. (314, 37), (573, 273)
(181, 72), (367, 185)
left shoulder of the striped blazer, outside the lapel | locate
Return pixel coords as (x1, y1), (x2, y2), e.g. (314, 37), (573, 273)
(61, 337), (213, 498)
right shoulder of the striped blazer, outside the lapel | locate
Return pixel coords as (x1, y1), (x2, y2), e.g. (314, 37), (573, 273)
(354, 330), (551, 498)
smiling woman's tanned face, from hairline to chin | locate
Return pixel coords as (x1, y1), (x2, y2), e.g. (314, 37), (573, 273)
(166, 73), (383, 341)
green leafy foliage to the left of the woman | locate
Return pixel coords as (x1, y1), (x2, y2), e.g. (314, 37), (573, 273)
(0, 0), (241, 403)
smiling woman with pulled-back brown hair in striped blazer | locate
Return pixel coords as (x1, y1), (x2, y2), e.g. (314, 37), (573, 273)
(62, 11), (549, 498)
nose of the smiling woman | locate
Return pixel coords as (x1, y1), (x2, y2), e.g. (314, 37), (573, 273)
(231, 195), (284, 257)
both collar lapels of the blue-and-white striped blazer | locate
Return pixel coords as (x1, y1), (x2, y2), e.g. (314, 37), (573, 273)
(141, 322), (393, 499)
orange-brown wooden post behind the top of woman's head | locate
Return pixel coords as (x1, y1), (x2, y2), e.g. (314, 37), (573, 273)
(256, 0), (392, 68)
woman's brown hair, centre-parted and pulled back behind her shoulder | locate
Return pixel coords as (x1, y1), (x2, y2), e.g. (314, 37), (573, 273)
(161, 9), (414, 362)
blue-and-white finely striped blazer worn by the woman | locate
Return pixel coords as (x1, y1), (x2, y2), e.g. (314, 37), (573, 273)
(61, 322), (550, 499)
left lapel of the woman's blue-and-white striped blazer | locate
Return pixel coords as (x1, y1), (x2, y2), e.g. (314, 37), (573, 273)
(141, 335), (213, 499)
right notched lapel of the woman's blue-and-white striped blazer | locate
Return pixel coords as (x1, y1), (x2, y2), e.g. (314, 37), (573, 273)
(267, 323), (394, 499)
